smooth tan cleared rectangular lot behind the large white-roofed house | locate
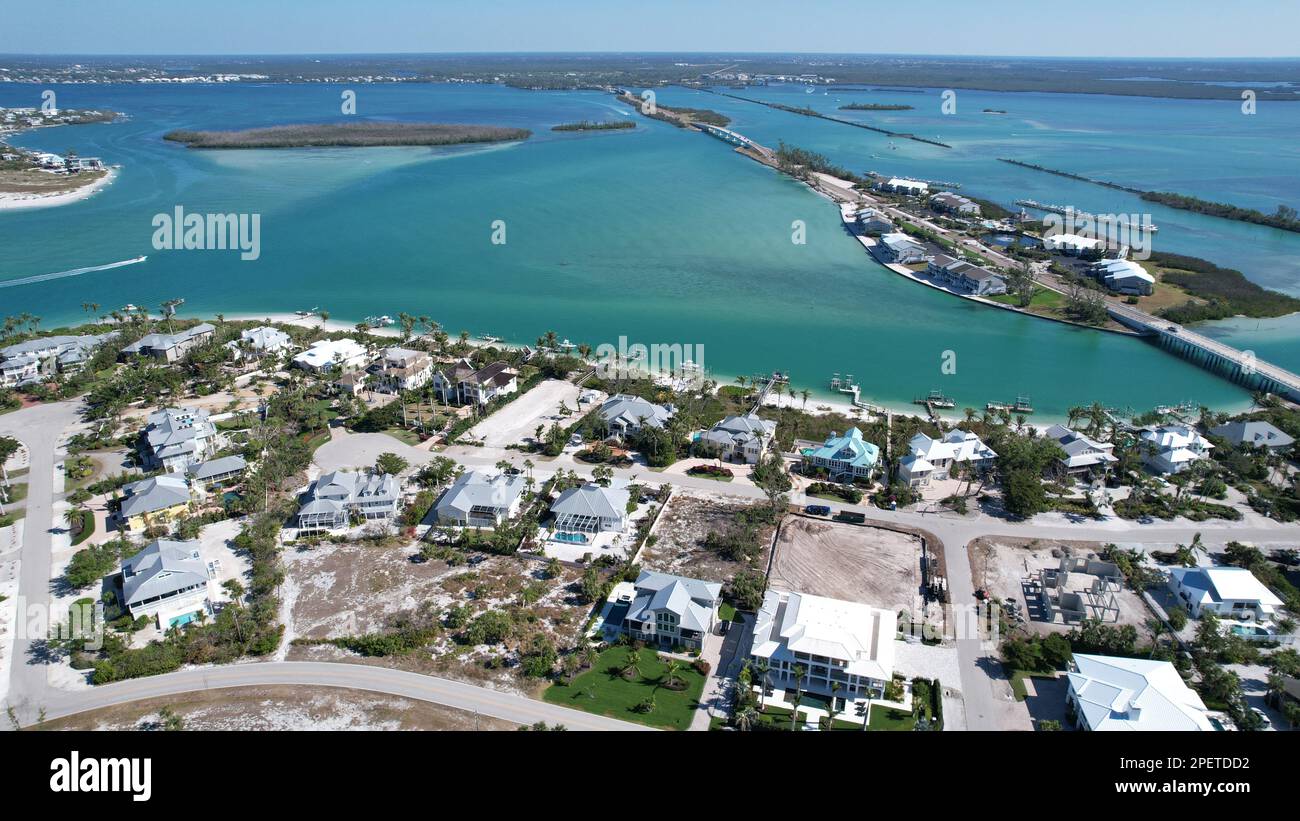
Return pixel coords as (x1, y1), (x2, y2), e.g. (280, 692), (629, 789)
(770, 516), (920, 611)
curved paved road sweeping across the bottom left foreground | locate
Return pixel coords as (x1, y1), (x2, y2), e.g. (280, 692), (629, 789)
(40, 661), (650, 730)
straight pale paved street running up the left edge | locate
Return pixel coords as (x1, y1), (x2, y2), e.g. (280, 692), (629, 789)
(0, 401), (81, 716)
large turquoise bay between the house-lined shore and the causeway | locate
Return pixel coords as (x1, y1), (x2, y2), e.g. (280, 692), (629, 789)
(0, 86), (1281, 418)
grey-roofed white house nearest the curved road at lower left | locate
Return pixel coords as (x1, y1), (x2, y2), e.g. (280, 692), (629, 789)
(122, 539), (212, 630)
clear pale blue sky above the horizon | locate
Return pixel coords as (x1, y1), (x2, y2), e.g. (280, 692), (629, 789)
(0, 0), (1300, 57)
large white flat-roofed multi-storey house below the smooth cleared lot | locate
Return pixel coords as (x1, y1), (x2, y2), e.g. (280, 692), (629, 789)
(750, 590), (898, 701)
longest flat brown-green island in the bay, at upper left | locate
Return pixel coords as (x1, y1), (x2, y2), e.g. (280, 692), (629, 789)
(163, 122), (533, 148)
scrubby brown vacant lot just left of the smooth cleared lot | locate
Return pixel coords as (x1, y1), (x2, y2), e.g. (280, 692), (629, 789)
(641, 490), (772, 582)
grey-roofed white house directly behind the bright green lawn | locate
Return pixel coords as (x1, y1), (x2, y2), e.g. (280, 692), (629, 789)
(606, 570), (723, 650)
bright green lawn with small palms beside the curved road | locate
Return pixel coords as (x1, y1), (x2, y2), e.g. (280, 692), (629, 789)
(542, 644), (705, 730)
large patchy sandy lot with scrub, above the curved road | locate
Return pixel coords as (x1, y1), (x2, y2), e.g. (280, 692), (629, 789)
(282, 544), (590, 692)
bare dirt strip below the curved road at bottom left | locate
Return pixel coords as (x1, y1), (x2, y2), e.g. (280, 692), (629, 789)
(42, 686), (515, 730)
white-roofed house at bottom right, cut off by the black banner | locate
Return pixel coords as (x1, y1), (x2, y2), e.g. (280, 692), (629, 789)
(1066, 653), (1214, 731)
